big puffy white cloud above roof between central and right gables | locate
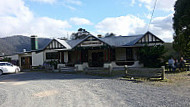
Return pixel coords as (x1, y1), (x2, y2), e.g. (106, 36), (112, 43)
(95, 15), (146, 35)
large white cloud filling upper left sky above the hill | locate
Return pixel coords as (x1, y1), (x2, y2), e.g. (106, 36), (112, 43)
(0, 0), (71, 37)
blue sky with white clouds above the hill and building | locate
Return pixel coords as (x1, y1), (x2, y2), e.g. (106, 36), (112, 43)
(0, 0), (176, 42)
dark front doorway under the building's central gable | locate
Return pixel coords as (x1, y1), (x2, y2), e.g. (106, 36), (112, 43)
(92, 52), (104, 67)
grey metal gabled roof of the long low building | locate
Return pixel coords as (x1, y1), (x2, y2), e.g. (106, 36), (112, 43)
(40, 32), (164, 50)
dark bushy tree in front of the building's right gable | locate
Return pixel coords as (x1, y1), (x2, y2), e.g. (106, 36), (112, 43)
(139, 45), (166, 68)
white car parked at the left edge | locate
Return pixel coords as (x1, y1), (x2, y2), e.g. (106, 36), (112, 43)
(0, 62), (20, 75)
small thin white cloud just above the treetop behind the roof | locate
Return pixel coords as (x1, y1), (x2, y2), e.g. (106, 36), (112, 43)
(70, 17), (93, 25)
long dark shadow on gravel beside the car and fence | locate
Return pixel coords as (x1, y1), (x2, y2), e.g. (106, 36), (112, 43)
(0, 71), (110, 82)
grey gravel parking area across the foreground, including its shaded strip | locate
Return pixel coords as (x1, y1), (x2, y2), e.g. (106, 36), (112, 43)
(0, 72), (190, 107)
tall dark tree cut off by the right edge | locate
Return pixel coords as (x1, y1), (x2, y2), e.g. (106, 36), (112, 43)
(173, 0), (190, 58)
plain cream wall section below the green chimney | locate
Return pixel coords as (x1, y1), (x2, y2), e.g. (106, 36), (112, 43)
(32, 51), (44, 66)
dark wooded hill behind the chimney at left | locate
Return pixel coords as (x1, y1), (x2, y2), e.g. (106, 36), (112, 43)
(0, 35), (51, 55)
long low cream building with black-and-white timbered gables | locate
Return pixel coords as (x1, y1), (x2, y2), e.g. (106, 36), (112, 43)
(20, 32), (164, 69)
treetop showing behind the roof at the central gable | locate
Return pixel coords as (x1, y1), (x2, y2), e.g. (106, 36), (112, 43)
(71, 28), (90, 40)
